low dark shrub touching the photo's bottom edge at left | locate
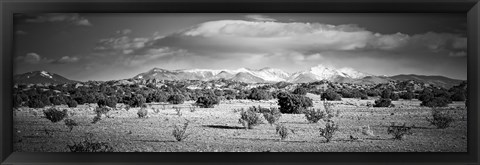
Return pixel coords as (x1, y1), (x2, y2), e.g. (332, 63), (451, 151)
(67, 133), (114, 152)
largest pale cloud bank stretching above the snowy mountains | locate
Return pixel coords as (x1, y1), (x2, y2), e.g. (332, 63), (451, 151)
(95, 20), (467, 67)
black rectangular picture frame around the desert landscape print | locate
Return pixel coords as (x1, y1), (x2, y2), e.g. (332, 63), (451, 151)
(0, 0), (480, 164)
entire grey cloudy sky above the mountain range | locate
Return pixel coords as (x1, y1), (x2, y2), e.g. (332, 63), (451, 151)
(14, 13), (467, 81)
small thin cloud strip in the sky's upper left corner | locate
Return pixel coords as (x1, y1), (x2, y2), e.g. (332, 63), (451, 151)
(25, 13), (92, 26)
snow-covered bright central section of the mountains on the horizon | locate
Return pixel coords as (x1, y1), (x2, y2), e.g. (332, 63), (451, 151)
(136, 64), (367, 83)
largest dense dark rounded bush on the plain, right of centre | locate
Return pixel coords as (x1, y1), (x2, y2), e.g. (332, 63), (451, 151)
(277, 93), (313, 114)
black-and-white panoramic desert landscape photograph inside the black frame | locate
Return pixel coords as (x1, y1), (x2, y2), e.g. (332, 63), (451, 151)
(12, 13), (468, 152)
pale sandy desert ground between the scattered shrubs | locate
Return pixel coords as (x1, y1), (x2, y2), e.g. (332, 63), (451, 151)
(14, 94), (467, 152)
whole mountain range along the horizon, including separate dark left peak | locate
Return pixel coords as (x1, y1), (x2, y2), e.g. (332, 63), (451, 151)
(14, 65), (464, 88)
